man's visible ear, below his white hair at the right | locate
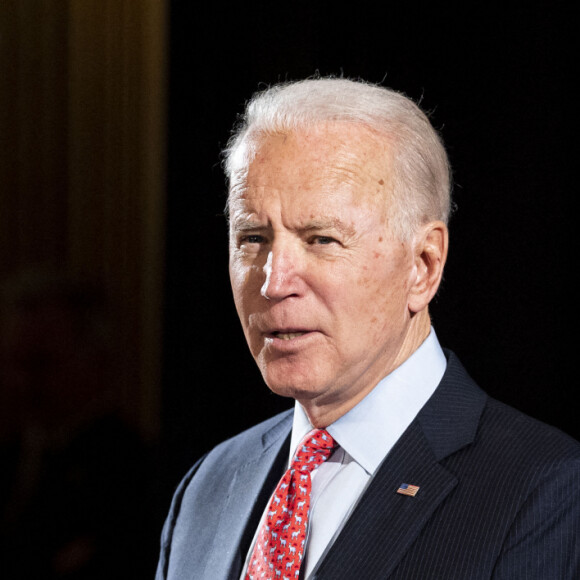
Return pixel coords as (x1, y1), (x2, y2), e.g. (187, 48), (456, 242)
(408, 221), (449, 314)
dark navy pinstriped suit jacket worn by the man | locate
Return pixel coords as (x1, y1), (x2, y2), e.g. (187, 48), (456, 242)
(157, 353), (580, 580)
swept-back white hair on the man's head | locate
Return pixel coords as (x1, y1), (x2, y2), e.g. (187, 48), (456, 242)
(224, 77), (451, 239)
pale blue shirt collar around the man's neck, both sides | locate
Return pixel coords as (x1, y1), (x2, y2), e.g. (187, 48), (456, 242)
(290, 328), (447, 475)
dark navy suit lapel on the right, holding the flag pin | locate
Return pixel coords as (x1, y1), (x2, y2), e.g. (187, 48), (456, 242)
(312, 355), (486, 580)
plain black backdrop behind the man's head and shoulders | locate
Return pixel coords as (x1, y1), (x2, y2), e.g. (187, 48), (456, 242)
(163, 0), (580, 486)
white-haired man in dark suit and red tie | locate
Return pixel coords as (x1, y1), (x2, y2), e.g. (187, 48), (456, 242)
(157, 79), (580, 580)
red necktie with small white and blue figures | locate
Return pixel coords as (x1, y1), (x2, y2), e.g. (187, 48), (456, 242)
(246, 429), (335, 580)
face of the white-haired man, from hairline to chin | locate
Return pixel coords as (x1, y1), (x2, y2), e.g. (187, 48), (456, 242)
(230, 123), (414, 418)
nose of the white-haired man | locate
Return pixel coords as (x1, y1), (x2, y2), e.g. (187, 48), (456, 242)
(260, 244), (300, 300)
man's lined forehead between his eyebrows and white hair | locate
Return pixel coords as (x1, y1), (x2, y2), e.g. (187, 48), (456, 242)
(229, 122), (391, 218)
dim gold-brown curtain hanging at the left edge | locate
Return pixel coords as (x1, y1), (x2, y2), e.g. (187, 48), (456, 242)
(0, 0), (167, 437)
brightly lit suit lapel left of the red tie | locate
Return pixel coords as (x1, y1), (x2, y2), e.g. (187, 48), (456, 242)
(204, 414), (292, 580)
